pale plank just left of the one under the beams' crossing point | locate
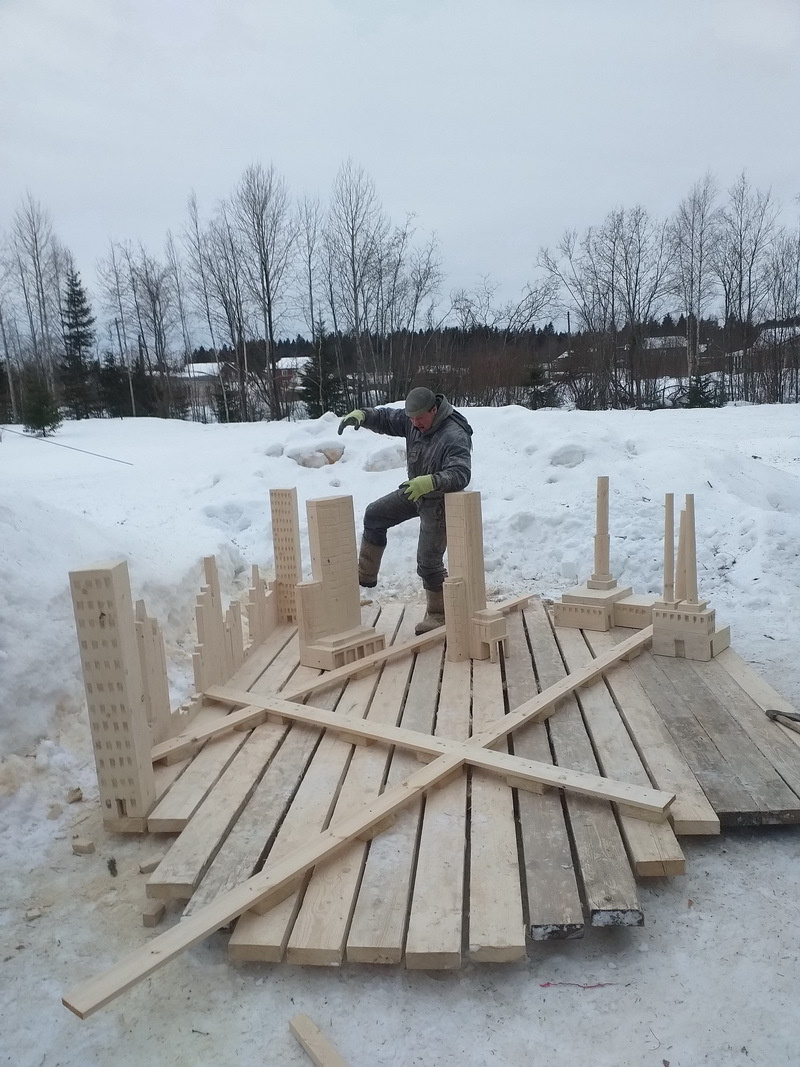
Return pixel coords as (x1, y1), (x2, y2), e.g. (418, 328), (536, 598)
(346, 643), (445, 964)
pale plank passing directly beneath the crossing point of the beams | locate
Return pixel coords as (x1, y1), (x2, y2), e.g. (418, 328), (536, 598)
(405, 659), (471, 970)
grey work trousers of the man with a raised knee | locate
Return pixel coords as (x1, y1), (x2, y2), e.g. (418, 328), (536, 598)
(364, 489), (447, 592)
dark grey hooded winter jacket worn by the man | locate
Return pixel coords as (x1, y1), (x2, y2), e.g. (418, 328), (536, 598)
(364, 393), (473, 496)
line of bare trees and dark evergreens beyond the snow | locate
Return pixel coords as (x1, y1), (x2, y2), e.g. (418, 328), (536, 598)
(0, 161), (800, 429)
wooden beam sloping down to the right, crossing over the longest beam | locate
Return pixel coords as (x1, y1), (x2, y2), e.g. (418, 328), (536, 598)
(206, 685), (675, 823)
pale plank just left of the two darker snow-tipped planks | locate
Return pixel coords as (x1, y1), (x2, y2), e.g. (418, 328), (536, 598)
(468, 659), (526, 964)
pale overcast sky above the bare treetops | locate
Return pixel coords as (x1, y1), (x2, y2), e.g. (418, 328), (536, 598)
(0, 0), (800, 328)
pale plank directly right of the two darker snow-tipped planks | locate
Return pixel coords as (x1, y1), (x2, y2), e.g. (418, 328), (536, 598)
(556, 626), (686, 877)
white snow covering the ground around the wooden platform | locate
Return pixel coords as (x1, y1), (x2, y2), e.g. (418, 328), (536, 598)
(0, 405), (800, 1067)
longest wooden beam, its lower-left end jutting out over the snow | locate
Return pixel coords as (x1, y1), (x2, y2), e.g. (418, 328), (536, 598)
(62, 626), (653, 1019)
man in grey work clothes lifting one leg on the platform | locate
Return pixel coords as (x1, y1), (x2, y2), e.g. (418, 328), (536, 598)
(339, 386), (473, 634)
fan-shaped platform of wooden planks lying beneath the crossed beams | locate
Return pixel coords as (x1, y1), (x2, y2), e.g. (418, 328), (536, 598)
(147, 601), (800, 970)
